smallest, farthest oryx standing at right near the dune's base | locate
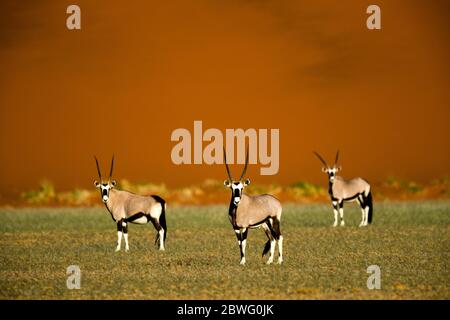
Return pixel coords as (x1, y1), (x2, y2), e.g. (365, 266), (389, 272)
(314, 150), (373, 227)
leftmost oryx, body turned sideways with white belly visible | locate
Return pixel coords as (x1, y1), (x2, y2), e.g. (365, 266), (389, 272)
(94, 156), (167, 251)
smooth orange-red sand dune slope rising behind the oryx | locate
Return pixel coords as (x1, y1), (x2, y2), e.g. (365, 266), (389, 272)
(0, 0), (450, 197)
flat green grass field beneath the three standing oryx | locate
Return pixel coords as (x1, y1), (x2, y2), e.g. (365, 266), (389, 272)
(0, 201), (450, 299)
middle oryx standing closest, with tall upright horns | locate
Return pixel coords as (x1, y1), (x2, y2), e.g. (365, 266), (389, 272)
(223, 147), (283, 265)
